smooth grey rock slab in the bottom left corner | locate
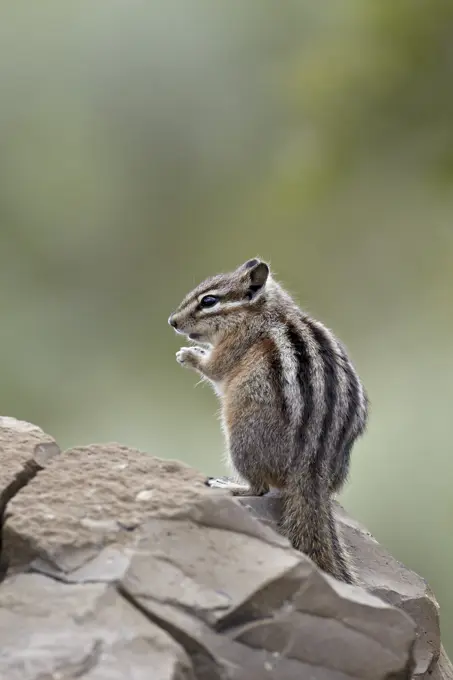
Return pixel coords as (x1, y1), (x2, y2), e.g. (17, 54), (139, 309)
(0, 574), (195, 680)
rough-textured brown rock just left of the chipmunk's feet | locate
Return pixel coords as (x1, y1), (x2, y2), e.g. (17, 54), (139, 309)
(3, 444), (207, 579)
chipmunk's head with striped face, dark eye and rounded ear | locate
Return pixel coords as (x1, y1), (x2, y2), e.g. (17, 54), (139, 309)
(168, 258), (271, 345)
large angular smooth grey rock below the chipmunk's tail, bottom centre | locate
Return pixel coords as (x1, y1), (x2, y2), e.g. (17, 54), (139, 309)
(122, 504), (414, 680)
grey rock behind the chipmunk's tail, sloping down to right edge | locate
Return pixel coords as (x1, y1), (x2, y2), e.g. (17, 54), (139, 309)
(240, 494), (453, 678)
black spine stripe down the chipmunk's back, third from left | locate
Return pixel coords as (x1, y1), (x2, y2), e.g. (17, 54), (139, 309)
(305, 318), (339, 461)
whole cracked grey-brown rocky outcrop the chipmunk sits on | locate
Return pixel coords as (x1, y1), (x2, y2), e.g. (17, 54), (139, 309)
(0, 419), (451, 680)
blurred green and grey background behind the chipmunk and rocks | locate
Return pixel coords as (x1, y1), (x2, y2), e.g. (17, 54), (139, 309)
(0, 0), (453, 655)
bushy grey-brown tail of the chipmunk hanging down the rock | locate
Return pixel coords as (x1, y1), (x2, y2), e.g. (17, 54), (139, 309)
(280, 474), (356, 583)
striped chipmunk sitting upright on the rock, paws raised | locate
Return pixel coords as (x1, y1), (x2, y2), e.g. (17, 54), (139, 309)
(168, 258), (369, 583)
